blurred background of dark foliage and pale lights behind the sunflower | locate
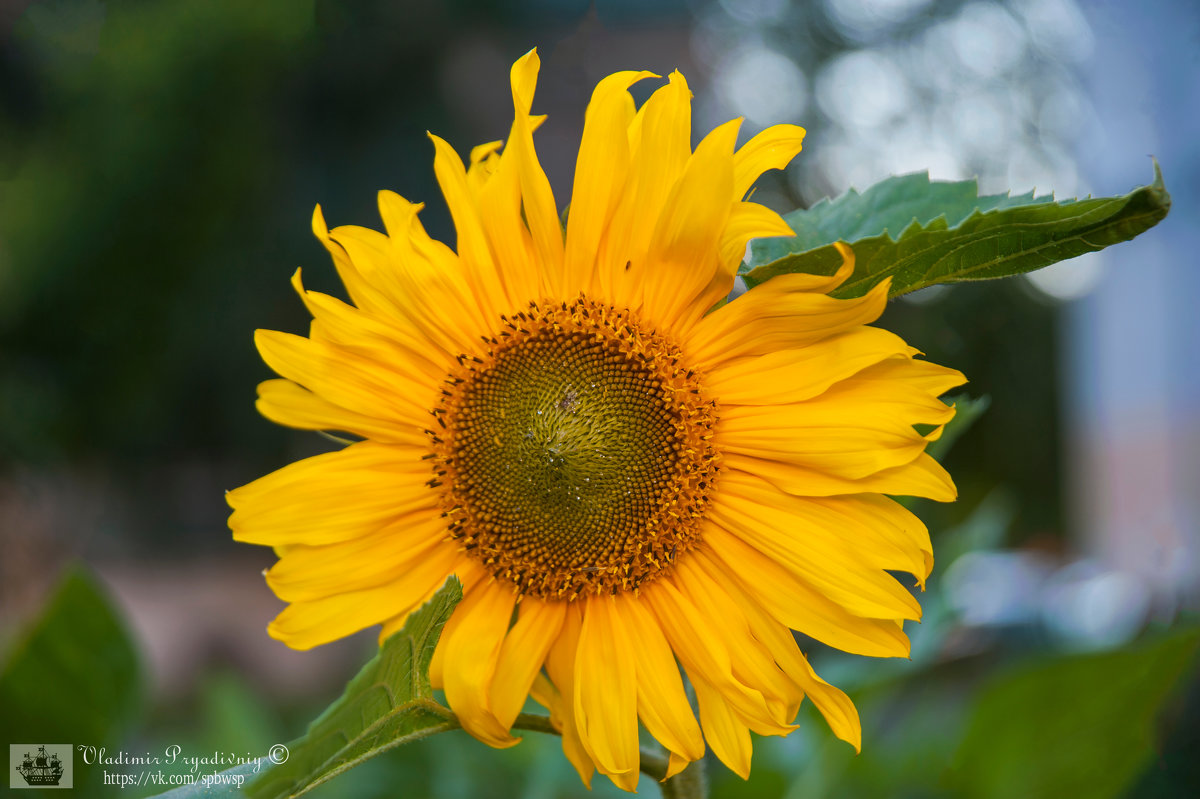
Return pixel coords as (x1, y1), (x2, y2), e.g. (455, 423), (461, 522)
(0, 0), (1200, 798)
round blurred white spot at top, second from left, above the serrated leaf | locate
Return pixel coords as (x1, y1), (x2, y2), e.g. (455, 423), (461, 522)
(817, 50), (912, 128)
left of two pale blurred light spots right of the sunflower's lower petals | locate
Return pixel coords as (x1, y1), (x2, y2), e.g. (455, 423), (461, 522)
(944, 551), (1050, 626)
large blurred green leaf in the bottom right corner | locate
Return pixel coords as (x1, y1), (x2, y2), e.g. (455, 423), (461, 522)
(947, 629), (1200, 799)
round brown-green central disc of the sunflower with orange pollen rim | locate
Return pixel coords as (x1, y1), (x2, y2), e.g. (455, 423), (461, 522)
(431, 298), (718, 599)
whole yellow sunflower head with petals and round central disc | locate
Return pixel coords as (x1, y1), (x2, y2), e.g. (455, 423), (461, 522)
(228, 52), (964, 791)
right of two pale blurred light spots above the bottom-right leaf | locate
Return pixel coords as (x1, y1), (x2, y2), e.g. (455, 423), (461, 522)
(1043, 560), (1151, 649)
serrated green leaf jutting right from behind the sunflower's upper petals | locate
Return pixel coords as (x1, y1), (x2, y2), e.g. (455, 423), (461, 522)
(740, 162), (1171, 298)
